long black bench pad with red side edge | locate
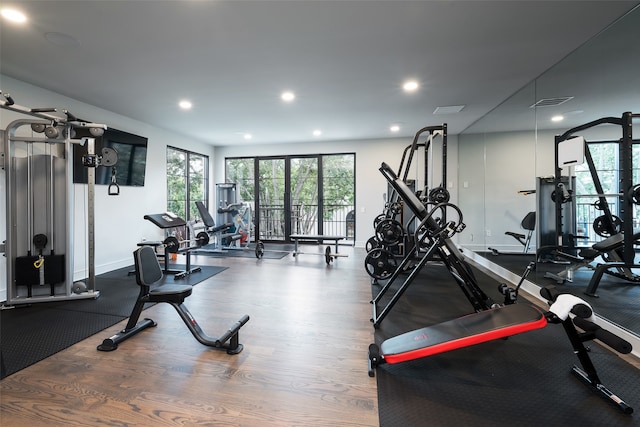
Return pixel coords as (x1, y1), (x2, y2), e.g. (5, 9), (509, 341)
(380, 304), (547, 363)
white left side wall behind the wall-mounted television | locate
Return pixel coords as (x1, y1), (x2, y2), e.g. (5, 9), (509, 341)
(0, 76), (214, 301)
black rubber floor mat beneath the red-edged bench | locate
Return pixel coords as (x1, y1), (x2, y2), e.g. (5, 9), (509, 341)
(376, 265), (640, 427)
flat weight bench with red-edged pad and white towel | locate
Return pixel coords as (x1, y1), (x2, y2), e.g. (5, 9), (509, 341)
(368, 288), (633, 414)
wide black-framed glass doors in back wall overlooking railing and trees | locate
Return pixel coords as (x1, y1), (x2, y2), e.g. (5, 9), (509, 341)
(225, 154), (355, 242)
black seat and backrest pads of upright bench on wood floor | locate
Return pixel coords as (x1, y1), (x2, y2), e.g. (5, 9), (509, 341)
(133, 246), (193, 304)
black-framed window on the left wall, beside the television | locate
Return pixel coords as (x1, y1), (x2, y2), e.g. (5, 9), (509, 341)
(167, 147), (209, 221)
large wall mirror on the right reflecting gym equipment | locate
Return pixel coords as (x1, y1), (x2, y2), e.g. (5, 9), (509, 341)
(458, 7), (640, 335)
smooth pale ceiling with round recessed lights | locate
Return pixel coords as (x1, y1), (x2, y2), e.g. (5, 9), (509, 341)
(0, 0), (638, 145)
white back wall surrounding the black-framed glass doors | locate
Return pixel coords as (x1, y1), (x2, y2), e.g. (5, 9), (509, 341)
(213, 134), (458, 247)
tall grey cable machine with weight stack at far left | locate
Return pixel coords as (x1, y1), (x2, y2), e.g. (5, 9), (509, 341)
(0, 93), (119, 308)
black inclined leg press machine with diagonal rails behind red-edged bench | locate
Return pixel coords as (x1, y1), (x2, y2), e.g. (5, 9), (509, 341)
(365, 163), (498, 327)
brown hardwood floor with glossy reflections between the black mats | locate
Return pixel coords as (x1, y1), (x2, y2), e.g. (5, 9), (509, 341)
(0, 246), (378, 427)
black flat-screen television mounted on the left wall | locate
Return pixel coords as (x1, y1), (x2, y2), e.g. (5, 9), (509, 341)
(73, 128), (148, 187)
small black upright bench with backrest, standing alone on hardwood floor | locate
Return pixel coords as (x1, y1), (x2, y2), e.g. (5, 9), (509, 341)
(98, 246), (249, 354)
